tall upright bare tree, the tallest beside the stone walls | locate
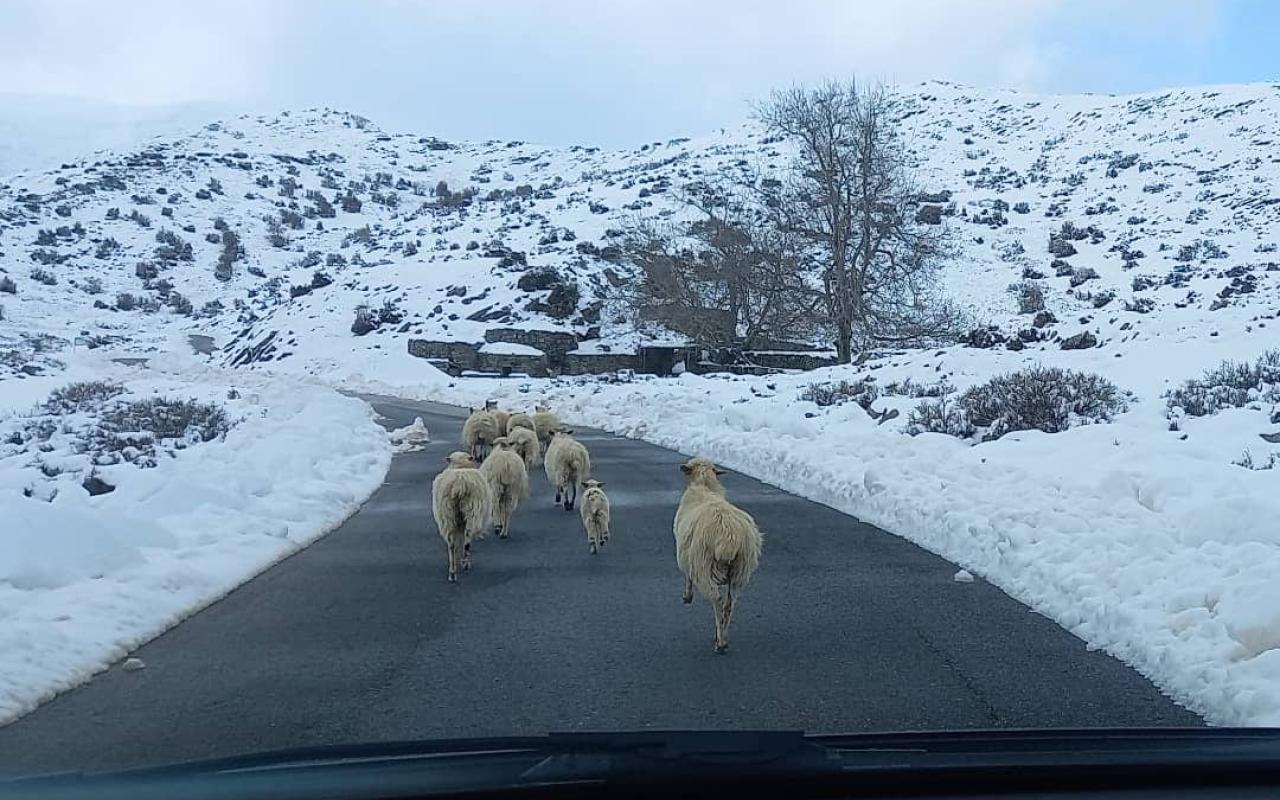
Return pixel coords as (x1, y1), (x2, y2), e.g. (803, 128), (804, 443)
(756, 81), (957, 362)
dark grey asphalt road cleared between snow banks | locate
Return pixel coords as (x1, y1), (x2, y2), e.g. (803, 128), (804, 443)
(0, 399), (1201, 773)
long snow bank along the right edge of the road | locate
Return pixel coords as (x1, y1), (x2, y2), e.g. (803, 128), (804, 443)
(378, 360), (1280, 726)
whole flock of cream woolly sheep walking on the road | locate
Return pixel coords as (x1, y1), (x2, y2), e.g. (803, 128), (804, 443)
(431, 402), (763, 653)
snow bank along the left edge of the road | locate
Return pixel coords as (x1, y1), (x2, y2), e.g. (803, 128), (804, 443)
(0, 356), (390, 722)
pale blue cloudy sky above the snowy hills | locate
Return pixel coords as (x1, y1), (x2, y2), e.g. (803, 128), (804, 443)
(0, 0), (1280, 146)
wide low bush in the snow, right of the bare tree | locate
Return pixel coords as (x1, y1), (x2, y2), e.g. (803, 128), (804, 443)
(908, 366), (1128, 442)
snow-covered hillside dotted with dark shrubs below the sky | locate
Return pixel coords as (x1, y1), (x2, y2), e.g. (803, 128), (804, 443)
(0, 83), (1280, 389)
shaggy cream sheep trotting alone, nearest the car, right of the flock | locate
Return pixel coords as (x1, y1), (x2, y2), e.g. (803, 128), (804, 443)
(672, 458), (763, 653)
